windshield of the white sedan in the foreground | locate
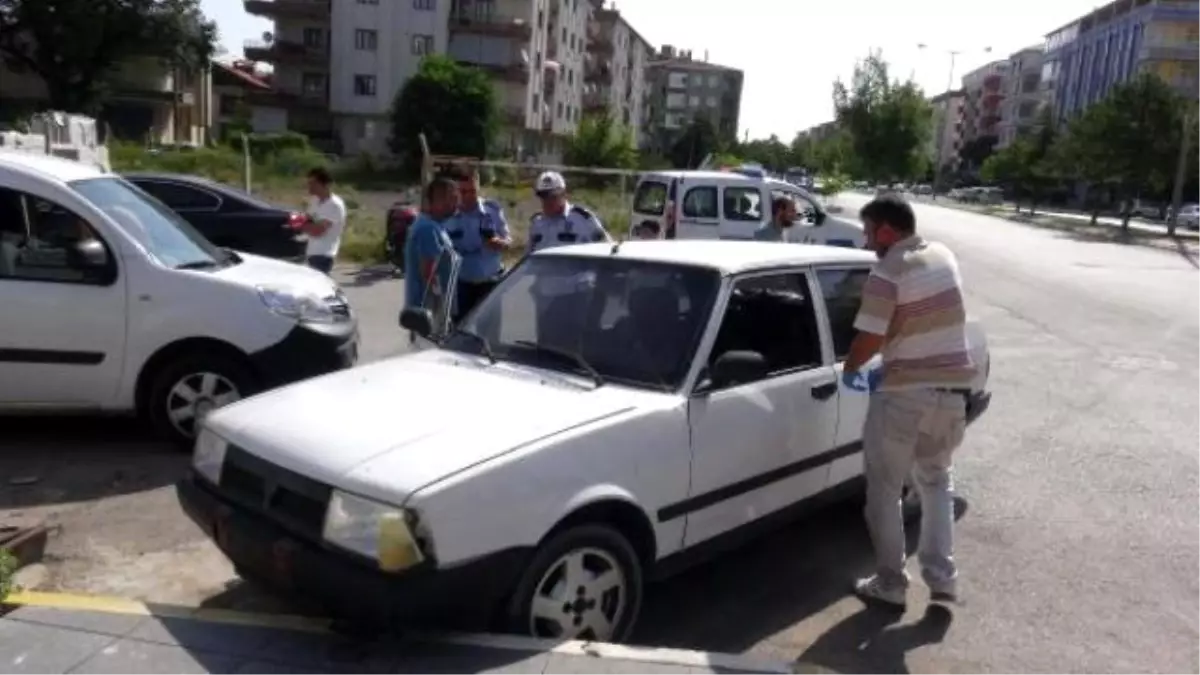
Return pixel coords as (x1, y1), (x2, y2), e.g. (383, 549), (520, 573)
(444, 255), (720, 392)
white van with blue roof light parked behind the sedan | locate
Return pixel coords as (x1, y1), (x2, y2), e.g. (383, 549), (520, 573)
(630, 171), (866, 249)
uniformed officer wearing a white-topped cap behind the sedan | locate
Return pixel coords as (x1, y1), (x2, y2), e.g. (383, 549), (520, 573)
(528, 171), (612, 348)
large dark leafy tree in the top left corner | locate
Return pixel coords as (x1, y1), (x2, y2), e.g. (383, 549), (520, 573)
(0, 0), (217, 114)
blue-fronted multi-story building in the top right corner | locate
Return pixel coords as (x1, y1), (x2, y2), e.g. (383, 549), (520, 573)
(1042, 0), (1200, 123)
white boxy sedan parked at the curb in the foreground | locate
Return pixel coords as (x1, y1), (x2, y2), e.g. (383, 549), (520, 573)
(178, 240), (990, 640)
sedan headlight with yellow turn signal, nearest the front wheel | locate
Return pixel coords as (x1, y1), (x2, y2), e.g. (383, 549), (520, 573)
(322, 490), (425, 572)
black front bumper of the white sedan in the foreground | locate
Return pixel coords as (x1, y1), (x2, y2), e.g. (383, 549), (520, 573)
(175, 474), (532, 629)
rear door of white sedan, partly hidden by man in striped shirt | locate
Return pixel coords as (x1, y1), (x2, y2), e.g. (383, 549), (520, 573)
(815, 265), (880, 488)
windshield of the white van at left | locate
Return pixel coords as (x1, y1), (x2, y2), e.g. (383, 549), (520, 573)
(70, 177), (230, 269)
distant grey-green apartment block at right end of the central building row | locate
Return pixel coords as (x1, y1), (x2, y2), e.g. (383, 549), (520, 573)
(647, 44), (744, 153)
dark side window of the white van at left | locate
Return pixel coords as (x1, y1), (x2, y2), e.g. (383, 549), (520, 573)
(0, 187), (113, 283)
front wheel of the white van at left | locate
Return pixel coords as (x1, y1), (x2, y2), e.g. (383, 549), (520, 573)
(145, 354), (254, 449)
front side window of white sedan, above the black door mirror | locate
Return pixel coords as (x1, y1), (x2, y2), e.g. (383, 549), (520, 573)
(708, 273), (823, 376)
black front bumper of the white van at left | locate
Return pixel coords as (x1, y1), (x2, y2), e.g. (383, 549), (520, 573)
(250, 321), (359, 388)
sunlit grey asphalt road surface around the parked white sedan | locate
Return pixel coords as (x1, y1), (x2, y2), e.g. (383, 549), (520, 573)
(0, 196), (1200, 675)
